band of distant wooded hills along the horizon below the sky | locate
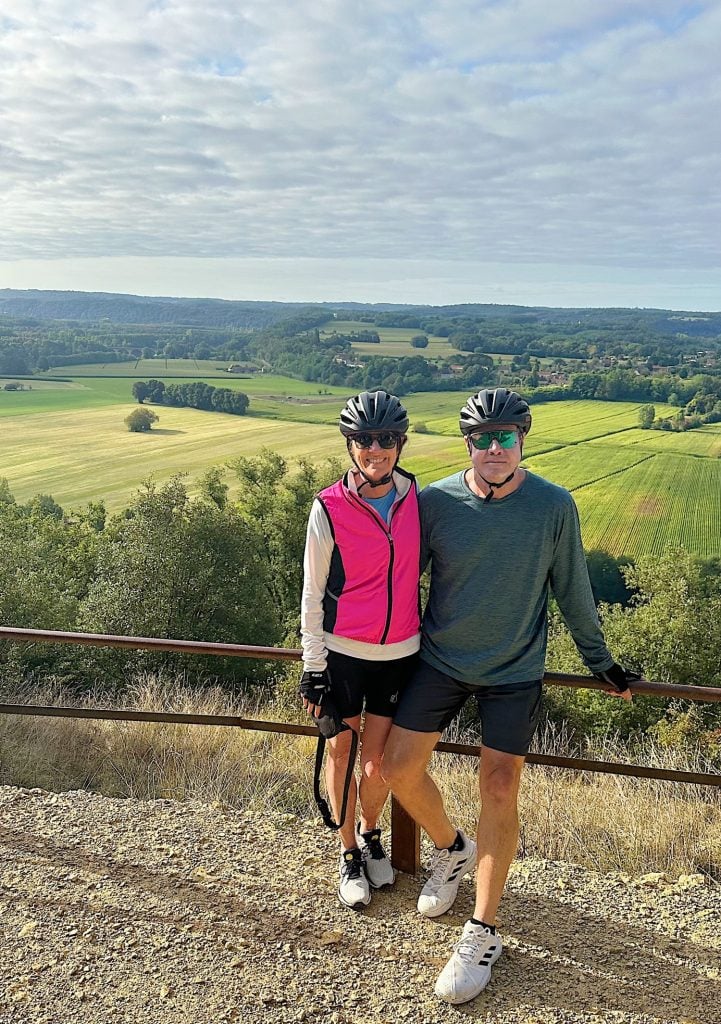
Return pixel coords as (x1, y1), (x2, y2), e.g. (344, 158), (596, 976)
(0, 289), (721, 413)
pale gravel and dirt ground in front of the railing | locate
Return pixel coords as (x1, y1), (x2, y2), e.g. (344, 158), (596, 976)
(0, 786), (721, 1024)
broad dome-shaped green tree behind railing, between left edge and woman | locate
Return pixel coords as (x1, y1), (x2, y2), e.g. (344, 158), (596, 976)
(80, 477), (281, 685)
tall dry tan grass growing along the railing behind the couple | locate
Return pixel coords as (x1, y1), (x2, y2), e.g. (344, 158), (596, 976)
(0, 679), (721, 879)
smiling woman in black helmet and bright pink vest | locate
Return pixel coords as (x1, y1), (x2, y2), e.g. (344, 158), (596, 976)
(301, 391), (420, 909)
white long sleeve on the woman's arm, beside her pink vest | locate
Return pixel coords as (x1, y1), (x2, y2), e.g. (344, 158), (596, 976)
(300, 499), (333, 672)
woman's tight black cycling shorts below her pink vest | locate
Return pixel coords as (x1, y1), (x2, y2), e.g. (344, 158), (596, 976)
(328, 650), (418, 718)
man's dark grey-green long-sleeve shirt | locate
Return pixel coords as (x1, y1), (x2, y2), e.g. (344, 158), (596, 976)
(420, 470), (613, 686)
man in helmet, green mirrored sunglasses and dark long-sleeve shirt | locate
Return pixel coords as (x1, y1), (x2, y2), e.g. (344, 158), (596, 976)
(383, 388), (639, 1004)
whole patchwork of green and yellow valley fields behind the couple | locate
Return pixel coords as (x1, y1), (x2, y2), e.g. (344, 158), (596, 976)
(0, 370), (721, 557)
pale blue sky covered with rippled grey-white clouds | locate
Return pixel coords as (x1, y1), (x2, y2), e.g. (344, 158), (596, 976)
(0, 0), (721, 310)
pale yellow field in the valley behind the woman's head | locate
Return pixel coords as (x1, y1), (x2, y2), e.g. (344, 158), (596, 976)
(0, 402), (464, 509)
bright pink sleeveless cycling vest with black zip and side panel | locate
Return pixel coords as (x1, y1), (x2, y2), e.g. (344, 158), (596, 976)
(317, 468), (421, 644)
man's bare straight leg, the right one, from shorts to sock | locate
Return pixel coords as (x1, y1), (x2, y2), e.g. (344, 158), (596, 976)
(473, 746), (525, 925)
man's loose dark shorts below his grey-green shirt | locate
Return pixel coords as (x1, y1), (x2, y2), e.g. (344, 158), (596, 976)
(393, 659), (542, 756)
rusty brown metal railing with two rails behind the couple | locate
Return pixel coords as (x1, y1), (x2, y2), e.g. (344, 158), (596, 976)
(0, 626), (721, 873)
